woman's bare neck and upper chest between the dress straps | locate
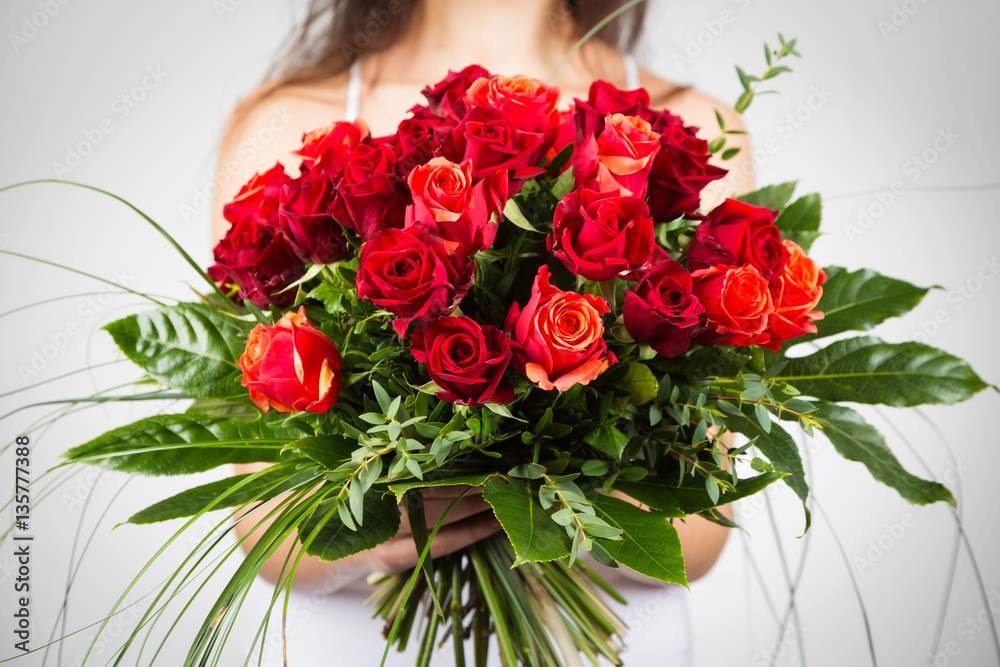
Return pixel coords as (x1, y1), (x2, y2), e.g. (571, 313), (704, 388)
(372, 0), (621, 87)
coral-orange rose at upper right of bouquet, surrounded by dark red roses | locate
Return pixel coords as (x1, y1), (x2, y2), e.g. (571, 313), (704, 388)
(573, 114), (660, 197)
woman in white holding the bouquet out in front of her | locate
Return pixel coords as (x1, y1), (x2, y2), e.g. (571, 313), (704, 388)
(213, 0), (753, 666)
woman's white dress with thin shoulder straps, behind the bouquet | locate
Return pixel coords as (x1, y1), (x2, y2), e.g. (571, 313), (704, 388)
(239, 54), (694, 667)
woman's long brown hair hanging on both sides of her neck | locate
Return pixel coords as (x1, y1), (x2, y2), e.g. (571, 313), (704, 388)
(268, 0), (646, 85)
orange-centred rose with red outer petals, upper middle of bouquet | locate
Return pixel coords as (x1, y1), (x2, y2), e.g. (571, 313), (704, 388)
(406, 157), (507, 255)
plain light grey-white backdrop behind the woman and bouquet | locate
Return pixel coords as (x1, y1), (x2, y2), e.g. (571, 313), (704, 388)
(0, 0), (1000, 667)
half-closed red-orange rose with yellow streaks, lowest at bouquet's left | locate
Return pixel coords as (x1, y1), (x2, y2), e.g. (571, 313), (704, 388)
(237, 308), (340, 412)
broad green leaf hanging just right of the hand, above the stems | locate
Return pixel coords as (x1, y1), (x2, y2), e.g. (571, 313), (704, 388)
(483, 479), (570, 566)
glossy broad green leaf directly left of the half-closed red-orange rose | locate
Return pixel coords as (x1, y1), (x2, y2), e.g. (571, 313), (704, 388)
(104, 303), (253, 400)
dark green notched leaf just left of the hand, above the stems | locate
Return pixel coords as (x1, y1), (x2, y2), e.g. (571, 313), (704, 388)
(299, 489), (400, 561)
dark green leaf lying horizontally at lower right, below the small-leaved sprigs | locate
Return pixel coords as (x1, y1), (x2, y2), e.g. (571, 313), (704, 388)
(614, 472), (787, 517)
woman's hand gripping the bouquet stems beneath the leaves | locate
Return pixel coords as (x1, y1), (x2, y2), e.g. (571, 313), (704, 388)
(359, 486), (500, 574)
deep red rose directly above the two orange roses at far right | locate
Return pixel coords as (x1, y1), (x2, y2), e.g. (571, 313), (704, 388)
(687, 199), (788, 280)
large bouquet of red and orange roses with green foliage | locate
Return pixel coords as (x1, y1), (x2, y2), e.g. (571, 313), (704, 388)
(27, 39), (987, 665)
